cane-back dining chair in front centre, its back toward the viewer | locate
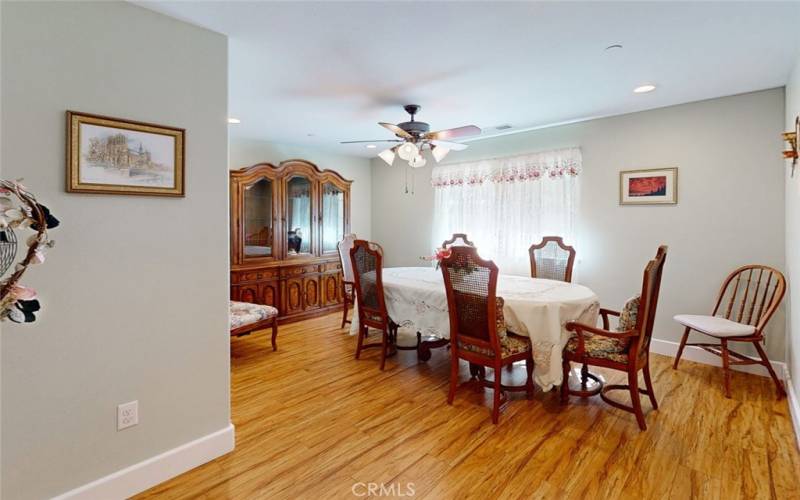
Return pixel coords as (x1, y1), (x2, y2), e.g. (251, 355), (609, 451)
(440, 246), (533, 424)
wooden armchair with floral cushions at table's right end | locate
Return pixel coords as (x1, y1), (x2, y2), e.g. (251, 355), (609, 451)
(561, 245), (667, 431)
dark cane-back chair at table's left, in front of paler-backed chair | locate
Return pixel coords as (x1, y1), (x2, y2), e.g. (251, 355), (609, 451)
(350, 240), (397, 370)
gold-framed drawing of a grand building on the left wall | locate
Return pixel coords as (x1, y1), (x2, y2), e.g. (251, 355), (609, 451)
(67, 111), (185, 196)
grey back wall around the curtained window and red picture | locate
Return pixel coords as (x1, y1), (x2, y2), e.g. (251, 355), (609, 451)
(372, 89), (785, 360)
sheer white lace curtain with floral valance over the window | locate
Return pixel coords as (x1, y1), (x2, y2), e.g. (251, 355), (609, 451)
(431, 148), (582, 275)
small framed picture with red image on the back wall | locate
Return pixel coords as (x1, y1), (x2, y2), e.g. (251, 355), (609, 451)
(619, 168), (678, 205)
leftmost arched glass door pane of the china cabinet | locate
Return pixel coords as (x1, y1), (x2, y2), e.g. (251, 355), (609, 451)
(243, 178), (275, 258)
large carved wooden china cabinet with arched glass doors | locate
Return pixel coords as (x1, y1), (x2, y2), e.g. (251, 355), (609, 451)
(230, 160), (352, 323)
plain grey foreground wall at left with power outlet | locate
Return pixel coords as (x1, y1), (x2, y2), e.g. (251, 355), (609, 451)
(0, 2), (230, 500)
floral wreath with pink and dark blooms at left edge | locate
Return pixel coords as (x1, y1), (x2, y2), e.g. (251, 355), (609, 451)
(0, 180), (59, 323)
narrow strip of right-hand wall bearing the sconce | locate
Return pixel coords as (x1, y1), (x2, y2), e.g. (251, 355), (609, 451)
(783, 59), (800, 394)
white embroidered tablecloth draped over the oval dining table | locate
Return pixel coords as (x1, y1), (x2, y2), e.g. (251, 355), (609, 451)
(350, 267), (600, 390)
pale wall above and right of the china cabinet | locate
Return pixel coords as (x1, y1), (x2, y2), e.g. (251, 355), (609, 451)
(229, 138), (372, 239)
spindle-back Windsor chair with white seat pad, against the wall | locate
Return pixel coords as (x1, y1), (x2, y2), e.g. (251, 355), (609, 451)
(672, 264), (786, 399)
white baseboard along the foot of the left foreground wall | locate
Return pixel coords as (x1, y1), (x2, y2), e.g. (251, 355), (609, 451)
(56, 424), (235, 500)
